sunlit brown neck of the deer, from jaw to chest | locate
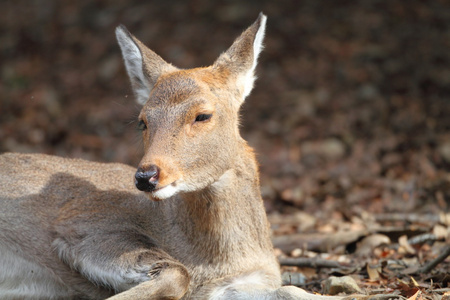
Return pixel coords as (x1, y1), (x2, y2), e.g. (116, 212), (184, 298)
(171, 146), (272, 262)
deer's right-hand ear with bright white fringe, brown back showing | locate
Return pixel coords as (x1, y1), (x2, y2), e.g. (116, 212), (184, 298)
(213, 13), (267, 101)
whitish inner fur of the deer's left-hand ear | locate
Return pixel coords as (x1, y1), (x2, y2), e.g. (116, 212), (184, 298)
(116, 27), (151, 105)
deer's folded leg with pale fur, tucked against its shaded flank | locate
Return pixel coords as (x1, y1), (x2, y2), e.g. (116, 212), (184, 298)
(53, 230), (190, 299)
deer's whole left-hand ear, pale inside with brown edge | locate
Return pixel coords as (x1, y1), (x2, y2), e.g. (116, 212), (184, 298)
(116, 25), (176, 105)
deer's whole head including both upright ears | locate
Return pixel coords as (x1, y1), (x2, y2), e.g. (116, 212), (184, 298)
(116, 14), (266, 200)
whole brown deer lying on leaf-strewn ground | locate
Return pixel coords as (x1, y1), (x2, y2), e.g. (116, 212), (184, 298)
(0, 14), (344, 300)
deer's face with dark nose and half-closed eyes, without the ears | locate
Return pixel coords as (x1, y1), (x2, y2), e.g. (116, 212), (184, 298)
(136, 68), (239, 199)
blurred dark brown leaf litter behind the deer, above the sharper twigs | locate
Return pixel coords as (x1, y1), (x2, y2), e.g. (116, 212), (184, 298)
(0, 0), (450, 220)
